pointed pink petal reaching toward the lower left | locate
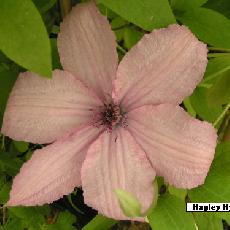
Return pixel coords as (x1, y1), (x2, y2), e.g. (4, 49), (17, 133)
(7, 127), (101, 206)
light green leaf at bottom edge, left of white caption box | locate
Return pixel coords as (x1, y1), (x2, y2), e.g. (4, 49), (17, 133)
(148, 194), (196, 230)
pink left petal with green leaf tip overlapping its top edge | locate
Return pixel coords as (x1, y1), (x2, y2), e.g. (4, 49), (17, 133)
(1, 70), (100, 143)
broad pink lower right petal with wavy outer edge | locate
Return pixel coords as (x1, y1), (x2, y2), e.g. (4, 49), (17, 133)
(128, 104), (217, 188)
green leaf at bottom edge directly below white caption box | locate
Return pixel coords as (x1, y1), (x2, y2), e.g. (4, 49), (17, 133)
(193, 212), (223, 230)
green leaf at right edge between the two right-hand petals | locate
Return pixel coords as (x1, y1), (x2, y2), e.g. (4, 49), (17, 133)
(190, 57), (230, 118)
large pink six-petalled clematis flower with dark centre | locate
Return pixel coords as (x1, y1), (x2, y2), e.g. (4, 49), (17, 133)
(2, 3), (217, 219)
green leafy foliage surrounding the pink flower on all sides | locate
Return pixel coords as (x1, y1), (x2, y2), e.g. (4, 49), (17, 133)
(0, 0), (230, 230)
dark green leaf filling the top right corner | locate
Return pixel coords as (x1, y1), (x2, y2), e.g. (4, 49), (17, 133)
(204, 0), (230, 19)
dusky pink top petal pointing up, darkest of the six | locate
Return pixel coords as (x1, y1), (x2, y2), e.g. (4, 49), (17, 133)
(58, 2), (118, 99)
